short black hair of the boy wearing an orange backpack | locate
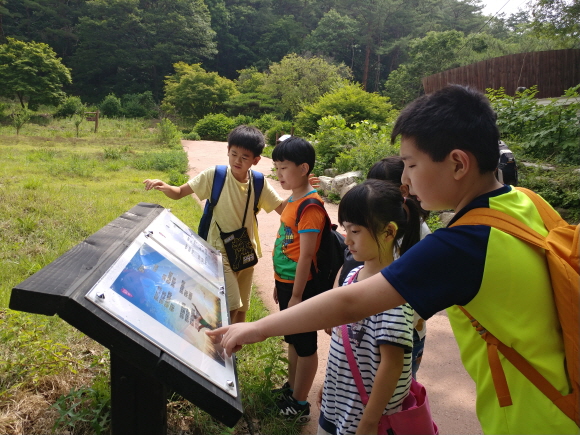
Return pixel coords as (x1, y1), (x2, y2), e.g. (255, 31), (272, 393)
(391, 85), (499, 174)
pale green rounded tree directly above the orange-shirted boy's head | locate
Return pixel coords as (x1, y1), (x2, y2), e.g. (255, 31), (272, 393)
(262, 54), (351, 116)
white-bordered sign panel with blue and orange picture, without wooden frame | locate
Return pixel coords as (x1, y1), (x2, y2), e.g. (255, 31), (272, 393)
(86, 210), (238, 397)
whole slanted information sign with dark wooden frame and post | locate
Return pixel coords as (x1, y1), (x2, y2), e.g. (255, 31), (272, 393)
(10, 203), (242, 434)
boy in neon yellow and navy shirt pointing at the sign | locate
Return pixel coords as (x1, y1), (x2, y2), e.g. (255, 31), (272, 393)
(208, 85), (579, 434)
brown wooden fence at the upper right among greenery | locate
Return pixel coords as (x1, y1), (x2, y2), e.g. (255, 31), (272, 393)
(423, 49), (580, 98)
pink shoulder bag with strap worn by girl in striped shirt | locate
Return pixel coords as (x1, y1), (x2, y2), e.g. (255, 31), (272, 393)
(341, 325), (439, 435)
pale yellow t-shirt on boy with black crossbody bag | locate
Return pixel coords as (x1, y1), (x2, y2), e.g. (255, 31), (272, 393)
(187, 166), (282, 257)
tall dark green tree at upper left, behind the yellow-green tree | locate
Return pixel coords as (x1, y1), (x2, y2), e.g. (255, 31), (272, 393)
(71, 0), (216, 102)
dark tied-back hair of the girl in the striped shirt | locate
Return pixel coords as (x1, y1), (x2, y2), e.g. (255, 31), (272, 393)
(338, 179), (421, 255)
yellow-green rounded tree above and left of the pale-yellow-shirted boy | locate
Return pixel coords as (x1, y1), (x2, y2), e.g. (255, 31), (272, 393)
(163, 62), (238, 119)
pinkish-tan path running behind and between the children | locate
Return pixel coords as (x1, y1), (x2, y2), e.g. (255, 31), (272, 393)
(182, 141), (482, 435)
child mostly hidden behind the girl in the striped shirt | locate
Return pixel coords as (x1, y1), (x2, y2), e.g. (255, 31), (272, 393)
(338, 156), (431, 379)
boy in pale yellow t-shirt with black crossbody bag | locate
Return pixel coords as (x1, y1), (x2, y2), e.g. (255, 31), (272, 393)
(143, 125), (286, 323)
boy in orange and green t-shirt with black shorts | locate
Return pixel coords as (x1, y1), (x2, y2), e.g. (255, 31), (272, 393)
(272, 137), (326, 423)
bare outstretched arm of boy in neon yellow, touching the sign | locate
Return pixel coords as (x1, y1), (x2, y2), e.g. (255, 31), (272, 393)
(207, 273), (405, 355)
